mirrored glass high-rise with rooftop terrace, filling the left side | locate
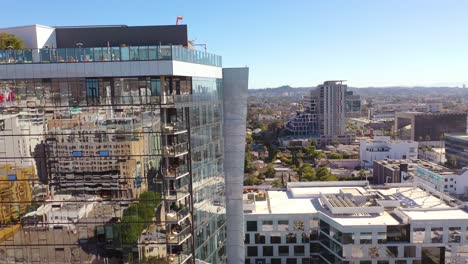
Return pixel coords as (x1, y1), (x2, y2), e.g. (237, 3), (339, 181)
(0, 25), (248, 263)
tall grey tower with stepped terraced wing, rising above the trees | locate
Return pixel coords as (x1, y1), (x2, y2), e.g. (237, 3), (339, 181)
(286, 81), (360, 145)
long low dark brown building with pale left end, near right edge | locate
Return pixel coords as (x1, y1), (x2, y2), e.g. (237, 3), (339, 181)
(395, 112), (467, 142)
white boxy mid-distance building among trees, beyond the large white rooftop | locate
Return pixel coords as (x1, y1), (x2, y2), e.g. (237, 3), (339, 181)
(360, 136), (418, 167)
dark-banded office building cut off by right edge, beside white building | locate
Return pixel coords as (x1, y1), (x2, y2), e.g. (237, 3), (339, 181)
(444, 133), (468, 168)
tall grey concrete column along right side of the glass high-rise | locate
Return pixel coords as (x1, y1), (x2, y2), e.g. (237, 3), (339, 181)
(223, 68), (249, 264)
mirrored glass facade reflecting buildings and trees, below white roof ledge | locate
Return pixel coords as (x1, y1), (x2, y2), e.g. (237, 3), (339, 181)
(0, 72), (226, 264)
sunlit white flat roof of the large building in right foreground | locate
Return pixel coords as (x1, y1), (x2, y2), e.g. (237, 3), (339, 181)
(244, 181), (468, 226)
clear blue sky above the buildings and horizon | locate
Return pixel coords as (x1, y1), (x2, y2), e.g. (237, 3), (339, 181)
(0, 0), (468, 88)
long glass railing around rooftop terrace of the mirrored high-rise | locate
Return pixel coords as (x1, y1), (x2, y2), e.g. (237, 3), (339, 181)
(0, 46), (222, 67)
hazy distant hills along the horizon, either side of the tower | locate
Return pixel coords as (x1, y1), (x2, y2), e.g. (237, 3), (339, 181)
(249, 85), (468, 98)
